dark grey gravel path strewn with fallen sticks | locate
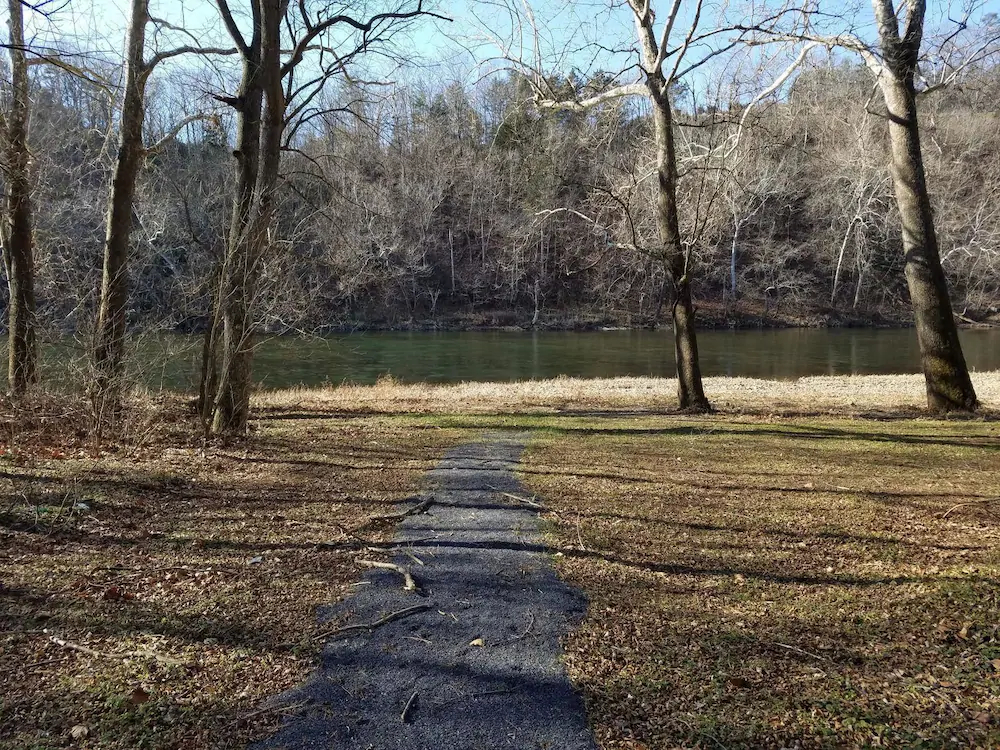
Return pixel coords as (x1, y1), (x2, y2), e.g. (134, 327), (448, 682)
(254, 434), (595, 750)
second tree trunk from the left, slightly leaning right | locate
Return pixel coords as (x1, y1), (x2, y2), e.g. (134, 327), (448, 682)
(92, 0), (149, 424)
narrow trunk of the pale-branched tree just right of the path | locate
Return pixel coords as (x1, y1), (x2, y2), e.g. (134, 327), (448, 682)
(652, 92), (712, 418)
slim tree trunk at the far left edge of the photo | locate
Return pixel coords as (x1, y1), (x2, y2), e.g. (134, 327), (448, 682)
(2, 0), (38, 395)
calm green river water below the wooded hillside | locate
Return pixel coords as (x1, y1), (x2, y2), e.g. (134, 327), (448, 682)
(25, 329), (1000, 390)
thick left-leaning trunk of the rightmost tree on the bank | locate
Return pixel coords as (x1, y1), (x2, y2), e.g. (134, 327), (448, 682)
(880, 72), (978, 412)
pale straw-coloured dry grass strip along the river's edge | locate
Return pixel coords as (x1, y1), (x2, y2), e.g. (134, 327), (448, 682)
(256, 372), (1000, 414)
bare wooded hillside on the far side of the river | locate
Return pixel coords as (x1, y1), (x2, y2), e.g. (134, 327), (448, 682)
(17, 47), (1000, 331)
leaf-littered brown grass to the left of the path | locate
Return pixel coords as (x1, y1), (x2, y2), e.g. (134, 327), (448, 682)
(0, 402), (460, 750)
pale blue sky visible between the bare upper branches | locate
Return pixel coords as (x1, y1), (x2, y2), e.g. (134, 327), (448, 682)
(11, 0), (1000, 106)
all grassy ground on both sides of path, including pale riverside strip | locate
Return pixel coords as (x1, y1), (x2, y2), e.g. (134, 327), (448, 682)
(0, 373), (1000, 750)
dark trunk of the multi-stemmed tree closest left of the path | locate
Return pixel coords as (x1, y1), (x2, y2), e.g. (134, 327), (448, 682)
(212, 0), (287, 435)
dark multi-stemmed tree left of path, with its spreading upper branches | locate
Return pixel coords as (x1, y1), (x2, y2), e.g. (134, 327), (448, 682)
(209, 0), (444, 435)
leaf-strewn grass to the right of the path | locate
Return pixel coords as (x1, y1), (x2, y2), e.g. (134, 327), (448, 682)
(524, 418), (1000, 750)
